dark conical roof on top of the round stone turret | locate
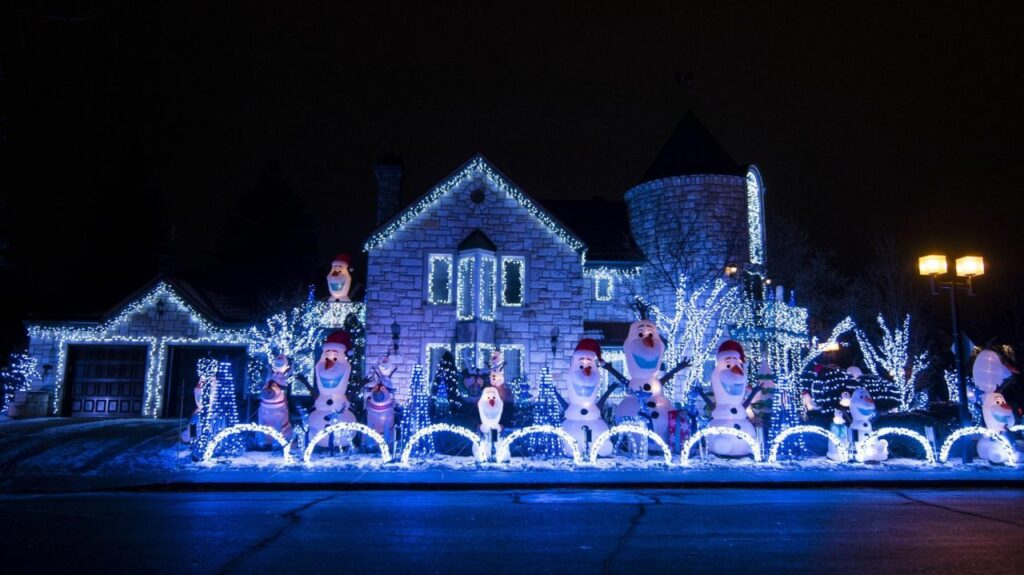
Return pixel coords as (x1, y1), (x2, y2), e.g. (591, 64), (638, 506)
(641, 110), (746, 183)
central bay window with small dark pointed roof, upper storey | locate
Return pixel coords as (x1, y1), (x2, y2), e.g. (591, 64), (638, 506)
(456, 229), (498, 321)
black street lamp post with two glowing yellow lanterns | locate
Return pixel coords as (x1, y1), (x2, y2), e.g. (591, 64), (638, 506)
(918, 254), (985, 463)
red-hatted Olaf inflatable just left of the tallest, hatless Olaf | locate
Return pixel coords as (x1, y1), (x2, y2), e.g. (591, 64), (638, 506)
(562, 339), (611, 457)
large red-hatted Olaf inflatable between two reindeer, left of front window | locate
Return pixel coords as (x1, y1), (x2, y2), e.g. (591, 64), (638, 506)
(309, 330), (355, 447)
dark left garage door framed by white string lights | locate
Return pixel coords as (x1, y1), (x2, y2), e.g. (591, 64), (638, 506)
(65, 346), (146, 417)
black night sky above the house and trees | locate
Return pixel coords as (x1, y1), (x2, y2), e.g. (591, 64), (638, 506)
(0, 0), (1024, 349)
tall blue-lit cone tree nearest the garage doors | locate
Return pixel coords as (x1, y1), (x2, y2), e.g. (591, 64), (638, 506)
(191, 357), (245, 460)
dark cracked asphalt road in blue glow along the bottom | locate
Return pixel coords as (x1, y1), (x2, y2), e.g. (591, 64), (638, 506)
(0, 489), (1024, 575)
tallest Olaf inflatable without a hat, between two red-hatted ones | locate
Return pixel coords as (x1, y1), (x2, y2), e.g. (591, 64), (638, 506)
(615, 319), (672, 441)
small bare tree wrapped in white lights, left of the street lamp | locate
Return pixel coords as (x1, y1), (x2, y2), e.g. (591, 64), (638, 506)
(854, 314), (929, 412)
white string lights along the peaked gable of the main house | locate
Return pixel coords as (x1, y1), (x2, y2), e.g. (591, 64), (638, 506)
(362, 154), (587, 252)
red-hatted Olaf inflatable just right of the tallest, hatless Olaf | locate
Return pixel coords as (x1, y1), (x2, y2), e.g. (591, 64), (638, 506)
(708, 340), (755, 456)
